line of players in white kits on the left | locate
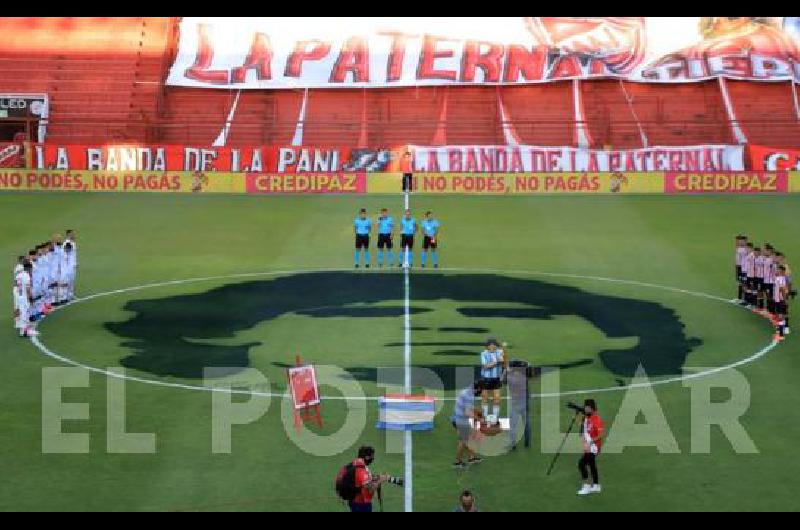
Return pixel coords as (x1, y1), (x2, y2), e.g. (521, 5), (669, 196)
(13, 230), (78, 337)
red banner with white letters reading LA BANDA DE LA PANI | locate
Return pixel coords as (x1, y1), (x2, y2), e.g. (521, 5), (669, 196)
(33, 144), (398, 173)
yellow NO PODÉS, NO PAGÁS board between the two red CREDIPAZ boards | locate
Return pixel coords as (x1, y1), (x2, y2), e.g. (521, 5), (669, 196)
(367, 172), (664, 195)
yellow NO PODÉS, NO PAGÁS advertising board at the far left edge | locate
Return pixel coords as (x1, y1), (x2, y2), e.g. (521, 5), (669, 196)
(0, 169), (245, 193)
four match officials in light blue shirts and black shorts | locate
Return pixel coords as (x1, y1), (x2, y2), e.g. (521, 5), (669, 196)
(353, 208), (441, 269)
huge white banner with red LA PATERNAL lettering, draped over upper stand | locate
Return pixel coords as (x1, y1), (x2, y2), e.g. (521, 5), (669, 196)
(167, 17), (800, 89)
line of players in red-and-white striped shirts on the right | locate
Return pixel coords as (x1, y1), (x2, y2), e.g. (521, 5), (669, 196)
(736, 235), (796, 340)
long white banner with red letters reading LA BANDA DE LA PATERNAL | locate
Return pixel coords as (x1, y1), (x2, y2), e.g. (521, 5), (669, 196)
(409, 145), (744, 173)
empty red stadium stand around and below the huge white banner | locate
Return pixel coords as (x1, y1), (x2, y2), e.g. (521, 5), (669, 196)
(0, 17), (800, 148)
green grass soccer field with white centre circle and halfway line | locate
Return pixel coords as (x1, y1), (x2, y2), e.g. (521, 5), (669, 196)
(0, 192), (800, 512)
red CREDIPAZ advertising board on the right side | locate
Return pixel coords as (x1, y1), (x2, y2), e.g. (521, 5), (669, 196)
(664, 171), (789, 193)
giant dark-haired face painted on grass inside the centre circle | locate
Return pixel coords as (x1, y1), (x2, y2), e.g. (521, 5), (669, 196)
(105, 272), (699, 389)
